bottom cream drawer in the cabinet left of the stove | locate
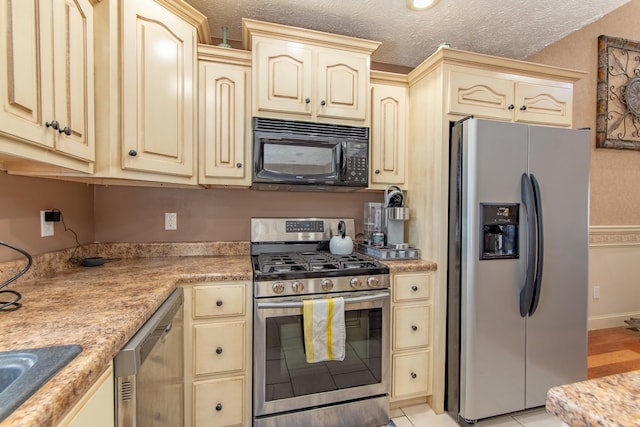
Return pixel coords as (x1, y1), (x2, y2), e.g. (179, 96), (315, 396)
(193, 376), (246, 427)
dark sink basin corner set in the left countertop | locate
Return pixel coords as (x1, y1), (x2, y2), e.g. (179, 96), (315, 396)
(0, 345), (82, 421)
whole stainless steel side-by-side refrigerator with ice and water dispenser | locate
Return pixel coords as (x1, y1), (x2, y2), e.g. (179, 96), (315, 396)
(446, 118), (590, 425)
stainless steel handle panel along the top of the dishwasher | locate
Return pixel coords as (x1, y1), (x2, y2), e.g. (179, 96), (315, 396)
(113, 288), (184, 377)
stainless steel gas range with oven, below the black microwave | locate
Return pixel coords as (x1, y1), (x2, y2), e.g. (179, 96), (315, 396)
(251, 218), (390, 427)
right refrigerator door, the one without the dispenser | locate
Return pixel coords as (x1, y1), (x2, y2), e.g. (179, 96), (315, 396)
(526, 126), (590, 408)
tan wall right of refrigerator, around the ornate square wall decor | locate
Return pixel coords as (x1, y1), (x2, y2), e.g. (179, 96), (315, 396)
(528, 0), (640, 225)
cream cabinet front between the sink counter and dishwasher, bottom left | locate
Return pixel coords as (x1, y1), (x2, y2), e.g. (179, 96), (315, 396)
(58, 363), (115, 427)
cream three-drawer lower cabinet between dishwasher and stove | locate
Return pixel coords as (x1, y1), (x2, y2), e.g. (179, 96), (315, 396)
(184, 281), (252, 427)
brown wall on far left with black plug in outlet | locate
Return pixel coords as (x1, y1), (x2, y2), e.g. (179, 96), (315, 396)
(0, 172), (94, 262)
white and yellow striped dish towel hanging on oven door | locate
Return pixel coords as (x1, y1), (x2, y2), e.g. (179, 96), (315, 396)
(302, 298), (346, 363)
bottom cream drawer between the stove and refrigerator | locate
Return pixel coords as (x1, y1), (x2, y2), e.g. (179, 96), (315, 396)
(391, 351), (431, 398)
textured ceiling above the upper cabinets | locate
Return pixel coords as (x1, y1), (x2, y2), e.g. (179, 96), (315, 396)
(186, 0), (629, 67)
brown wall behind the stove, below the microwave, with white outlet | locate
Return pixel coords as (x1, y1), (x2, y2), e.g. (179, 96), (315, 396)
(95, 186), (383, 242)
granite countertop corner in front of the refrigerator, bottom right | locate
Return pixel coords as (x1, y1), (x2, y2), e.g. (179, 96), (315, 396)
(546, 371), (640, 427)
